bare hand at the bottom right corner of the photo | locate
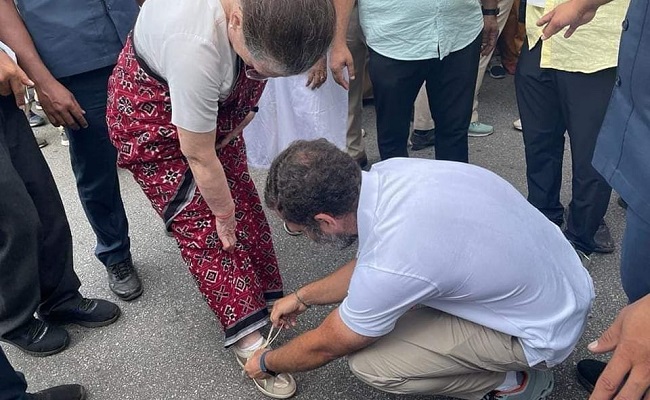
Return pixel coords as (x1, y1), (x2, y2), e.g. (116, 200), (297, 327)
(589, 295), (650, 400)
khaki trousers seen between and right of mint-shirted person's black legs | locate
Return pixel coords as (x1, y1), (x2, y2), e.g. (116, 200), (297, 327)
(413, 0), (514, 131)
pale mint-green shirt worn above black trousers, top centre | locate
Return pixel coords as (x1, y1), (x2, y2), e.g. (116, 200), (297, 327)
(359, 0), (483, 61)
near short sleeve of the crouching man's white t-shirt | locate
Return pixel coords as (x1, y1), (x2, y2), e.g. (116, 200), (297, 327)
(339, 265), (438, 337)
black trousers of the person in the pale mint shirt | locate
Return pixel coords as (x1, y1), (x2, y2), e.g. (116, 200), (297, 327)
(368, 35), (481, 162)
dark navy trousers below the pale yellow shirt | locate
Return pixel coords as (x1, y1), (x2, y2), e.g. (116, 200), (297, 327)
(515, 41), (616, 254)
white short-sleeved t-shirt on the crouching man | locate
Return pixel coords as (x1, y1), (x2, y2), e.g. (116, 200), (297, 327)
(339, 158), (594, 367)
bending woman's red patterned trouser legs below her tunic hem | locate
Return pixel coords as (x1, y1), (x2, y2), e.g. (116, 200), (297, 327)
(172, 138), (282, 346)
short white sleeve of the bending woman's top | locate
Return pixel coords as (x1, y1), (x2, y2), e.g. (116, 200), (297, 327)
(161, 33), (225, 133)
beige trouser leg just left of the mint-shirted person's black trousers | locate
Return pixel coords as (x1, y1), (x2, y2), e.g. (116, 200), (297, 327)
(346, 5), (368, 161)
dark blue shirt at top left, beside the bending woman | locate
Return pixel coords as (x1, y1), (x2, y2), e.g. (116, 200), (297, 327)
(16, 0), (139, 78)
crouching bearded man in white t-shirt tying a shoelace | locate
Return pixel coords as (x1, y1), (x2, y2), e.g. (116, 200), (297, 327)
(246, 140), (594, 400)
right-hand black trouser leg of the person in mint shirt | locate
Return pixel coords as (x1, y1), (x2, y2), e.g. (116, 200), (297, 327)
(426, 35), (481, 162)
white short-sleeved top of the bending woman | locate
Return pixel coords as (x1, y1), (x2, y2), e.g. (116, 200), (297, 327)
(134, 0), (237, 132)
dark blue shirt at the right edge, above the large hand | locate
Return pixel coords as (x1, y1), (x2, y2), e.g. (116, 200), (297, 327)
(593, 0), (650, 223)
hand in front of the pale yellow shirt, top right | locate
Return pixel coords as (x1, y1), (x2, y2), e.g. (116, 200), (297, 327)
(537, 0), (598, 40)
